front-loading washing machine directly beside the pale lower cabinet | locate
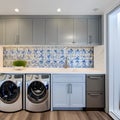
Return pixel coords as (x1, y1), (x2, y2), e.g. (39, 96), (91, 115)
(26, 74), (50, 112)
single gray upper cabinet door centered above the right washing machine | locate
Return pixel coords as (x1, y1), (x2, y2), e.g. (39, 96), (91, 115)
(33, 19), (45, 45)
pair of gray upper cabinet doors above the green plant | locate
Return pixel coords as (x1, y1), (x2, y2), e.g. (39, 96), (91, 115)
(5, 19), (32, 45)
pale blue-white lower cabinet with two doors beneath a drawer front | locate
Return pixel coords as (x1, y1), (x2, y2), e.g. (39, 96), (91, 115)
(52, 74), (85, 110)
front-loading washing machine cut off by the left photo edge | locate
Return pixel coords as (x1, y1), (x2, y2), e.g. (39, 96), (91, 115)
(0, 74), (23, 112)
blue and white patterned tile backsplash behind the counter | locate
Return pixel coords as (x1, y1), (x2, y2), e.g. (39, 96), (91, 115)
(3, 46), (94, 68)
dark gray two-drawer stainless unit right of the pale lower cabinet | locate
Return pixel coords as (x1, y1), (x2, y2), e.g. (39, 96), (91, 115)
(86, 74), (105, 109)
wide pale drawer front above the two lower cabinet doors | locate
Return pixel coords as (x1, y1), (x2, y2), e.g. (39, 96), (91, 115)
(52, 74), (85, 83)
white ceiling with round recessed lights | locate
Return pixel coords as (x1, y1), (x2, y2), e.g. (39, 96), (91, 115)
(0, 0), (120, 15)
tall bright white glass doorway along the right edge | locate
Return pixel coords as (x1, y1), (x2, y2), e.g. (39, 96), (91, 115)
(107, 7), (120, 120)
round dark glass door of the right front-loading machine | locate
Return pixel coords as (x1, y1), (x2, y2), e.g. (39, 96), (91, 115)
(27, 81), (48, 103)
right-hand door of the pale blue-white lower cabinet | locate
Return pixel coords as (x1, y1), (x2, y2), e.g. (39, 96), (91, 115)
(70, 83), (85, 107)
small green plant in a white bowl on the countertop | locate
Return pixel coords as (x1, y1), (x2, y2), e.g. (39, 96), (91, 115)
(13, 60), (27, 70)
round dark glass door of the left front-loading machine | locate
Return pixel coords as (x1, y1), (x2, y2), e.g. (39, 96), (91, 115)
(0, 81), (20, 104)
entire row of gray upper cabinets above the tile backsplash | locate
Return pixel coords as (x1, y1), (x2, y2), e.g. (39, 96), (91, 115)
(0, 16), (102, 46)
